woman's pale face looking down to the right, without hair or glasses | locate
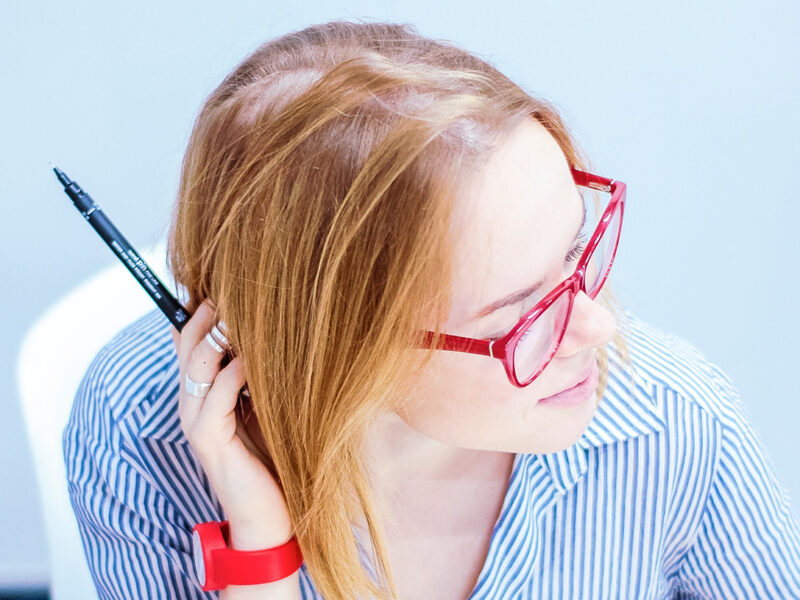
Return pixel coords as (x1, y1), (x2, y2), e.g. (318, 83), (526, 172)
(397, 119), (615, 453)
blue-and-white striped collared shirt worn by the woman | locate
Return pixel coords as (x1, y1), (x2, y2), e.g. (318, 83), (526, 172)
(63, 310), (800, 600)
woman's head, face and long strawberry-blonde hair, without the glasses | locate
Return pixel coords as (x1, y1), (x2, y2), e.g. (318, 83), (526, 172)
(168, 22), (628, 598)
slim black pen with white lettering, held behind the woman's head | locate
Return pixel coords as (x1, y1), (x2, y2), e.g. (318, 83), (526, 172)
(53, 166), (191, 331)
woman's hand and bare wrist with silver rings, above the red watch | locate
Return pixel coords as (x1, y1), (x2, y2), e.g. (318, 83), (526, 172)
(171, 300), (292, 550)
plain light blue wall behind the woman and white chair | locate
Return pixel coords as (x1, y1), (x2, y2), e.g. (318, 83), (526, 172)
(0, 0), (800, 588)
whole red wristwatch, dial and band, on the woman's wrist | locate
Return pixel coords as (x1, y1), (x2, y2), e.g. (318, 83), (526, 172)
(192, 521), (303, 592)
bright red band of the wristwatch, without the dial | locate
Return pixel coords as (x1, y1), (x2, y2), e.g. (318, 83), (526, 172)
(214, 521), (303, 585)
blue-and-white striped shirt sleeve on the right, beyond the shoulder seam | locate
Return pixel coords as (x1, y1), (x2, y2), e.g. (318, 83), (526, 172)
(674, 365), (800, 600)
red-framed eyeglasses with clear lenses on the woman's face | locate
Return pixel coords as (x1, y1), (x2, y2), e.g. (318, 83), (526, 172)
(418, 168), (627, 388)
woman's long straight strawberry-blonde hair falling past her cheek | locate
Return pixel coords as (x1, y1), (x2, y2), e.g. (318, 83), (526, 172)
(167, 21), (628, 600)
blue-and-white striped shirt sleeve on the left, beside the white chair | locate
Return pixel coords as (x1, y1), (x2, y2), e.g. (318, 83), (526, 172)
(62, 361), (218, 600)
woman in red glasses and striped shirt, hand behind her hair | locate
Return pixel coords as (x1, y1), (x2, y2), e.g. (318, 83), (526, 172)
(64, 22), (800, 600)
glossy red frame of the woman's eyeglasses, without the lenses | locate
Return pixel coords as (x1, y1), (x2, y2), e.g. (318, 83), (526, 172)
(418, 167), (627, 388)
